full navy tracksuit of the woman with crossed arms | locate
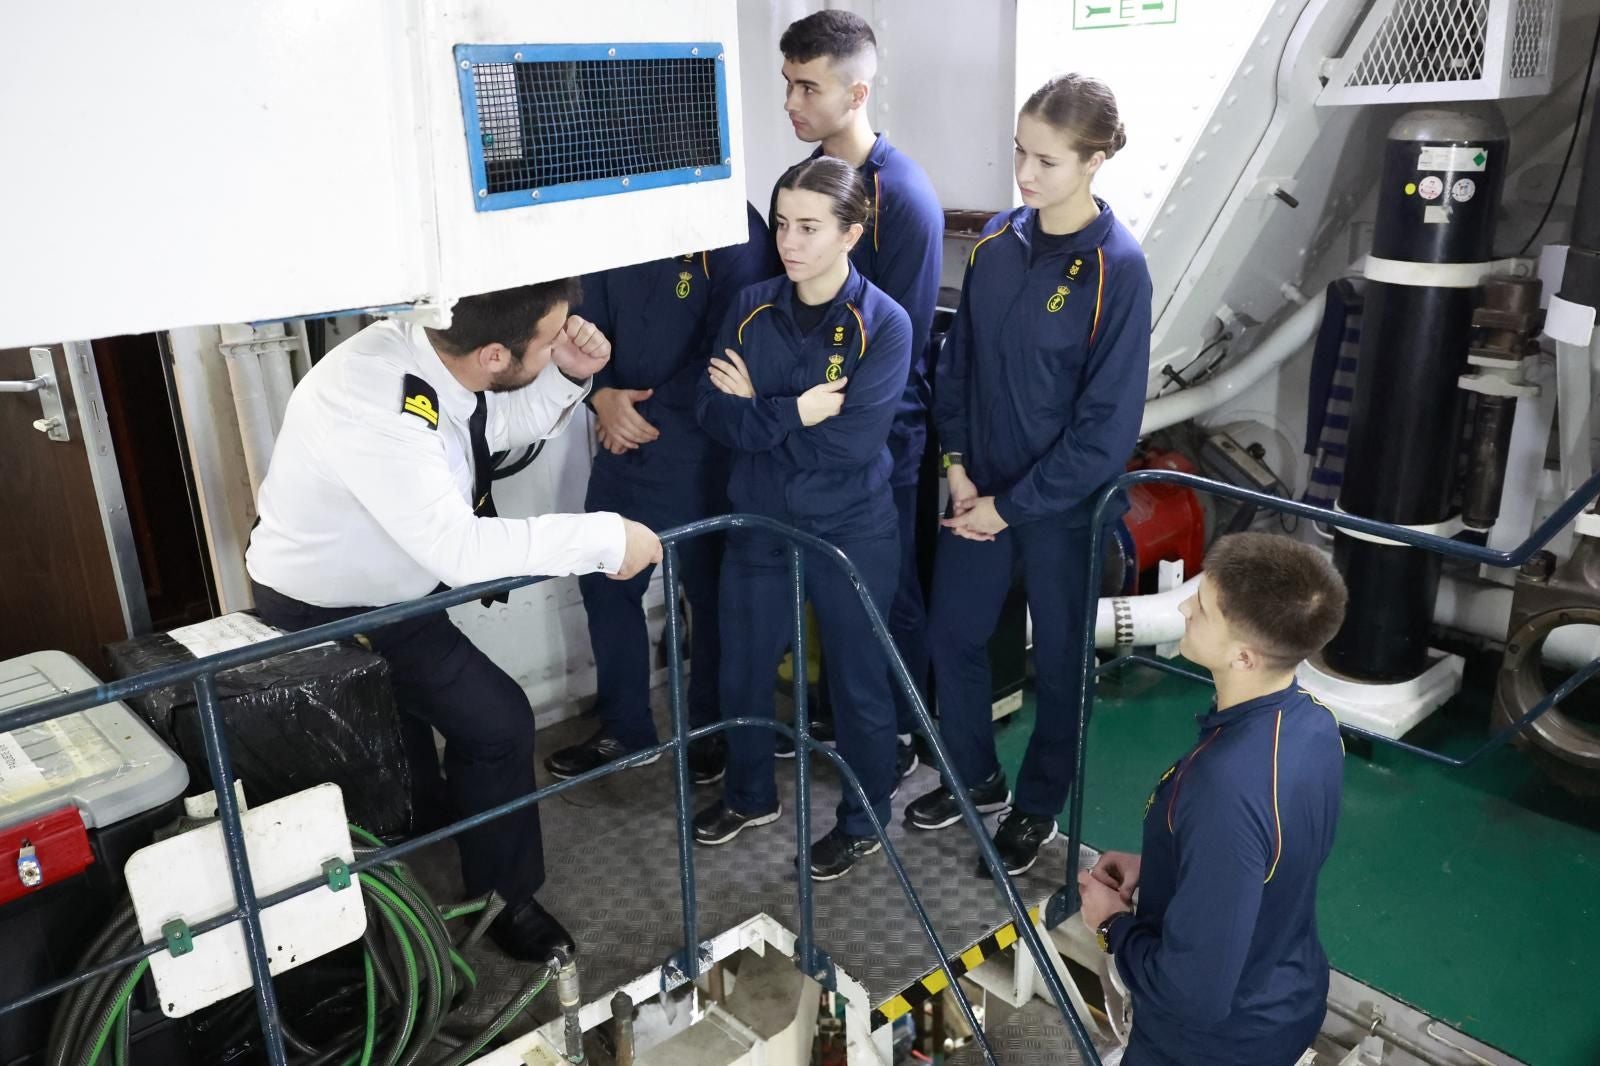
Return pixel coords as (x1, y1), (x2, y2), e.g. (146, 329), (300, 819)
(698, 267), (910, 837)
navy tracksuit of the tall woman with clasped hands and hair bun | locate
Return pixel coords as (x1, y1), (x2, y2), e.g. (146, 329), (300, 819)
(928, 203), (1150, 818)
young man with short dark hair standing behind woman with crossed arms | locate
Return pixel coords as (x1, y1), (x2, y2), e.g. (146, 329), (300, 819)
(768, 11), (944, 776)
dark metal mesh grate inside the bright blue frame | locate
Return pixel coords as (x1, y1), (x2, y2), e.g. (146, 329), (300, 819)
(472, 58), (725, 195)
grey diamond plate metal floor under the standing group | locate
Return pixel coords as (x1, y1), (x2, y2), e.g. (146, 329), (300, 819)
(403, 697), (1066, 1029)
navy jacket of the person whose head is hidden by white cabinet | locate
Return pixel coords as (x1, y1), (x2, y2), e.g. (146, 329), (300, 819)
(574, 203), (782, 467)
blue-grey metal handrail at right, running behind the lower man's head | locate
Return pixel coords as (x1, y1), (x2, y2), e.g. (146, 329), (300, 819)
(1045, 469), (1600, 928)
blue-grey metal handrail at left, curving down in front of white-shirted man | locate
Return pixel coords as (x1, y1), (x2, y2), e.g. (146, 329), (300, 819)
(0, 514), (1101, 1066)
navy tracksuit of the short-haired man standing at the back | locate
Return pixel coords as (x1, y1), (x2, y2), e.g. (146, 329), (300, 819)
(768, 133), (944, 733)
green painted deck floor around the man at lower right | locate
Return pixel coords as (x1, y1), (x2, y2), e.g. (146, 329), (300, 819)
(1000, 661), (1600, 1066)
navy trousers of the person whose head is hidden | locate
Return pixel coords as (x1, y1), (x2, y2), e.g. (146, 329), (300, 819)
(578, 445), (728, 751)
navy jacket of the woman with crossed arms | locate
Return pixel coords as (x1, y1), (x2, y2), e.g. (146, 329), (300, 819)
(696, 257), (910, 541)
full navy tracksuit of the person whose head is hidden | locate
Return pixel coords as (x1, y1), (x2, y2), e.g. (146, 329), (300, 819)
(578, 205), (779, 751)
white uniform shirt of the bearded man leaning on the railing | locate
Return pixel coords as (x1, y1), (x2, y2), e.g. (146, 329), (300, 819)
(245, 322), (626, 607)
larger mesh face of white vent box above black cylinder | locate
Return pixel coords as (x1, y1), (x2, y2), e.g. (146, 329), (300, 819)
(1346, 0), (1490, 88)
